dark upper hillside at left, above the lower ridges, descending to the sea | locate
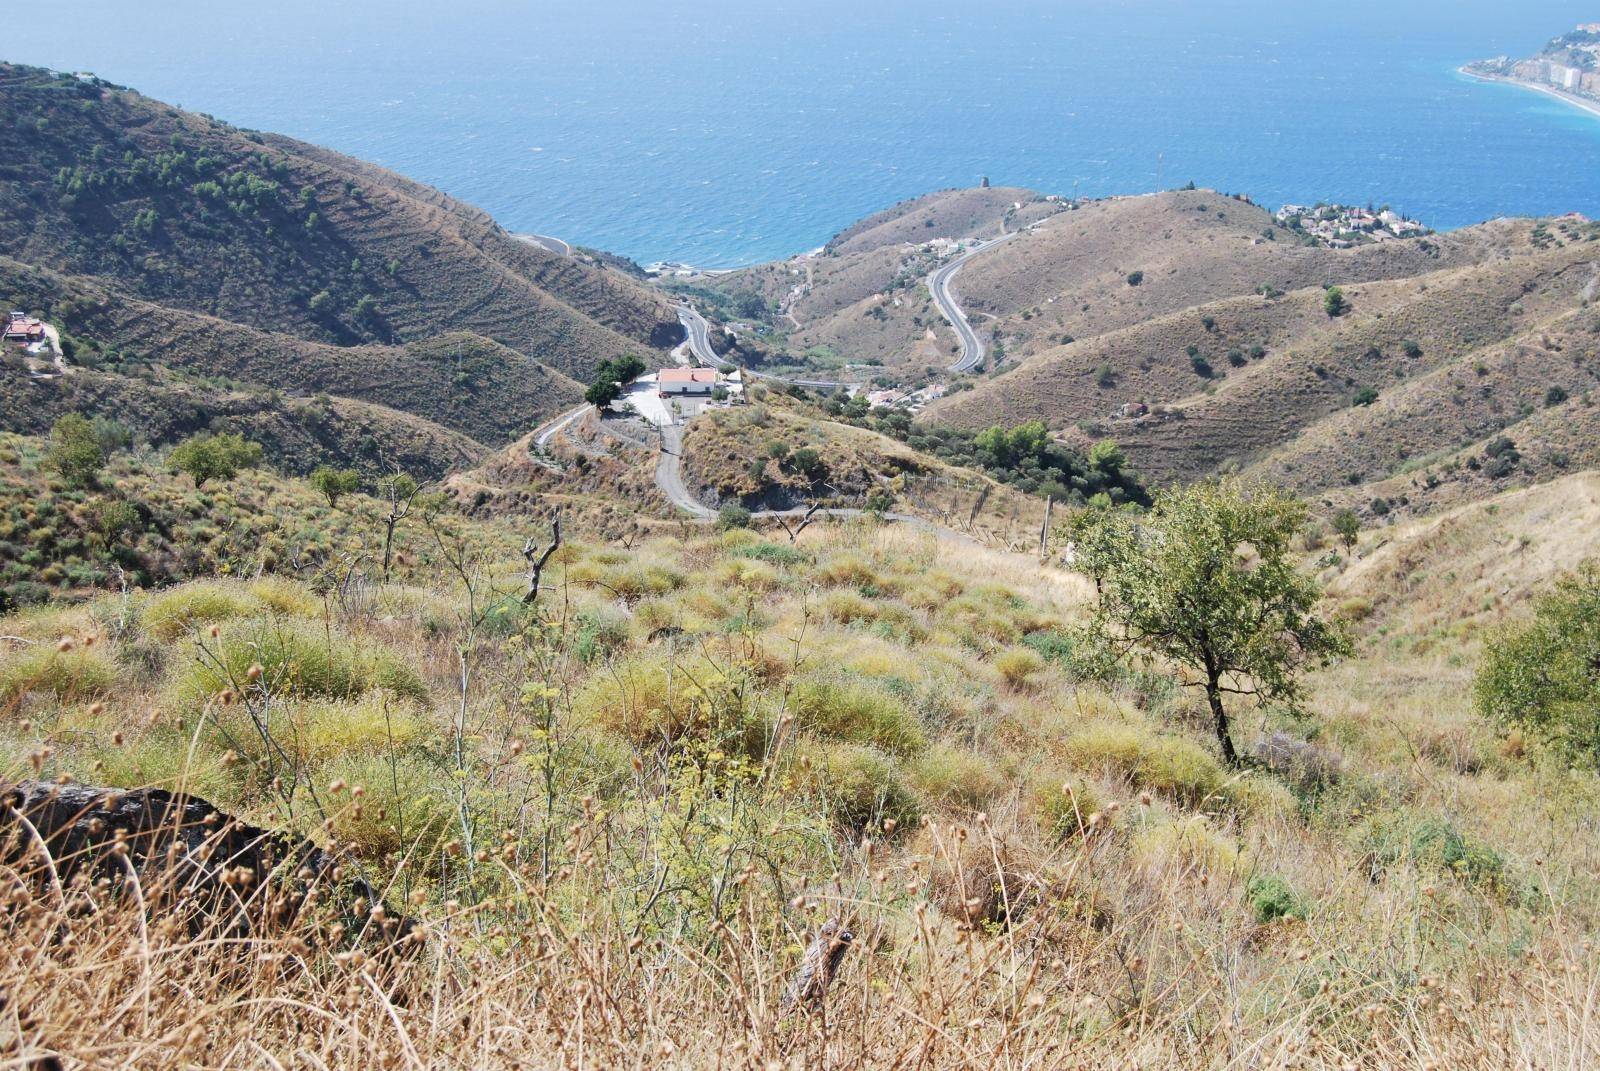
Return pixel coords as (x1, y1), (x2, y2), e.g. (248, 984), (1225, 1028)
(0, 66), (674, 376)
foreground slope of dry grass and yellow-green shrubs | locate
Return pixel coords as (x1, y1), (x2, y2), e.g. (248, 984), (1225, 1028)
(0, 458), (1600, 1071)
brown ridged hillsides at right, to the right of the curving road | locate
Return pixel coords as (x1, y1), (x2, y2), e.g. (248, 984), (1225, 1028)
(902, 192), (1600, 509)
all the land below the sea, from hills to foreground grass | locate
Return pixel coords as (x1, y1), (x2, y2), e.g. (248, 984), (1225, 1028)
(0, 56), (1600, 1071)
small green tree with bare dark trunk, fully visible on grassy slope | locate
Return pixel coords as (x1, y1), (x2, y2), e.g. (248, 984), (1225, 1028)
(1074, 482), (1349, 764)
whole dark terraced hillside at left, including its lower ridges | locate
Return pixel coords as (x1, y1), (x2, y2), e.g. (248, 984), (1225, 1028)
(0, 64), (682, 477)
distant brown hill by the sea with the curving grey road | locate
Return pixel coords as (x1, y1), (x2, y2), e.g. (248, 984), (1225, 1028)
(694, 191), (1526, 383)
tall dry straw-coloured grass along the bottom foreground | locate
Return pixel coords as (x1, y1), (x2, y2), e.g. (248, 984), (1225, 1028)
(0, 794), (1600, 1071)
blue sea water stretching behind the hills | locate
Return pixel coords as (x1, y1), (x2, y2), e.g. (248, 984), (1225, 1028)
(18, 0), (1600, 267)
